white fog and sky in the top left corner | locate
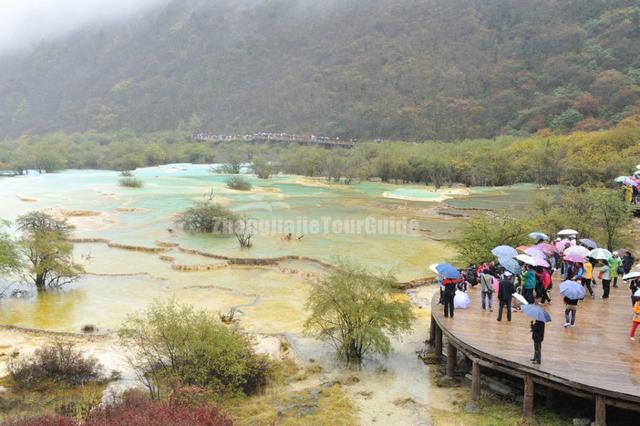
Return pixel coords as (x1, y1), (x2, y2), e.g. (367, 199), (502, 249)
(0, 0), (167, 54)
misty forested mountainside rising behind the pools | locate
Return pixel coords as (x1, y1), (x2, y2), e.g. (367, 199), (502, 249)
(0, 0), (640, 140)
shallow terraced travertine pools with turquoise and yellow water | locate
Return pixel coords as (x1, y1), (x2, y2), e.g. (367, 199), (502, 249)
(0, 164), (535, 423)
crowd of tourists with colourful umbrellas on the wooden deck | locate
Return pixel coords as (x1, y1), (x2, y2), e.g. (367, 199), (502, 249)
(430, 229), (640, 364)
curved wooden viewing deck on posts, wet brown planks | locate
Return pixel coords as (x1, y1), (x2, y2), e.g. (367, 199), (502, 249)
(431, 283), (640, 425)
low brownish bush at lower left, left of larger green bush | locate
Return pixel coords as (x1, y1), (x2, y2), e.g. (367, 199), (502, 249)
(7, 342), (103, 388)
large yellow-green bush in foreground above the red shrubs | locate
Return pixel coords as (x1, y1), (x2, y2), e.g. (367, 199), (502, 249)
(119, 301), (273, 398)
